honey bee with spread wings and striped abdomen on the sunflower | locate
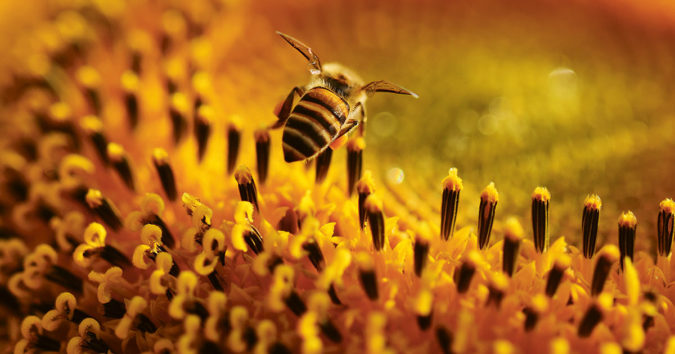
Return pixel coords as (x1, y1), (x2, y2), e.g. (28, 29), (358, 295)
(270, 31), (417, 162)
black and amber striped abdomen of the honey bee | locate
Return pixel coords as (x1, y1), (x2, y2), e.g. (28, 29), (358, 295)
(282, 87), (349, 162)
